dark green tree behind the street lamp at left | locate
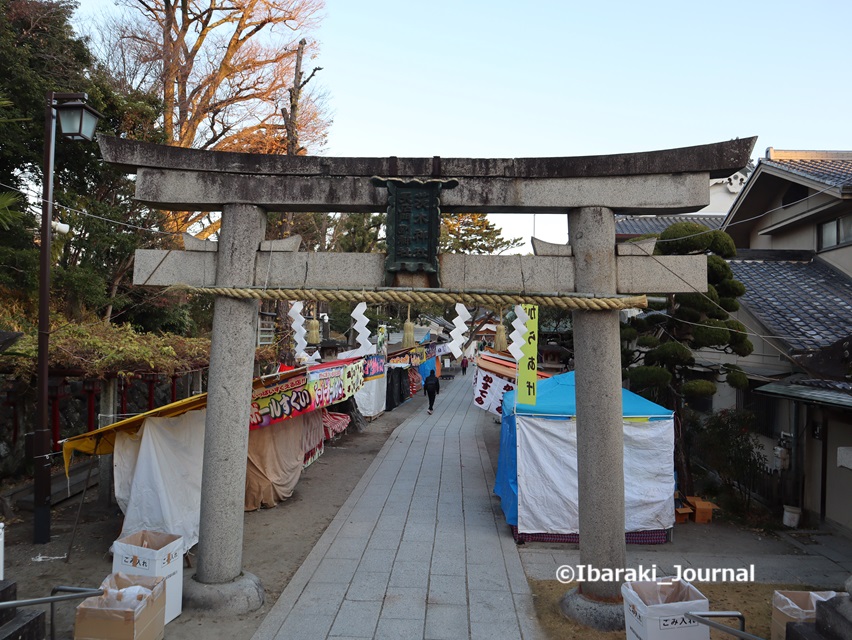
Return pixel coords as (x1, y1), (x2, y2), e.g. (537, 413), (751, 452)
(0, 0), (198, 336)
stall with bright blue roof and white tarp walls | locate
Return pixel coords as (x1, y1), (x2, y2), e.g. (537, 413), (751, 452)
(494, 372), (675, 544)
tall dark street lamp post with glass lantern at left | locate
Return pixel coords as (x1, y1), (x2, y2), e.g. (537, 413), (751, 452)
(33, 91), (101, 544)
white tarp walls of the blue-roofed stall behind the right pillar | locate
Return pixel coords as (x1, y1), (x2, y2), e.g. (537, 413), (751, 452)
(517, 415), (675, 535)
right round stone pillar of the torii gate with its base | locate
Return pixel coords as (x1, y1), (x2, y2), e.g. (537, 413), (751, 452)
(562, 207), (627, 630)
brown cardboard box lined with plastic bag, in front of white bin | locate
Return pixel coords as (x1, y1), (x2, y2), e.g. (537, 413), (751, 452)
(74, 573), (166, 640)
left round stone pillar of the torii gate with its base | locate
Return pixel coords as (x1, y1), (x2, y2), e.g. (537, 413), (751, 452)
(184, 204), (266, 613)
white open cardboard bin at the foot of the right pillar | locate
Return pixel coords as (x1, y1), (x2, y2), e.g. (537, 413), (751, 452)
(621, 580), (710, 640)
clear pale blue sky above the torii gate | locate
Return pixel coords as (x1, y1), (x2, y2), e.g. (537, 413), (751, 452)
(75, 0), (852, 248)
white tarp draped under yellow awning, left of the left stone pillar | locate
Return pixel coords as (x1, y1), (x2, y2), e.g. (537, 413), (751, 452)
(113, 409), (207, 549)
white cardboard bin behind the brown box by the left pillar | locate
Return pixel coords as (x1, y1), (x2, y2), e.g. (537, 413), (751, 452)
(112, 531), (183, 624)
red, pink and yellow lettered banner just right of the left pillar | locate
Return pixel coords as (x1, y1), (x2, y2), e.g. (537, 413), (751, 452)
(249, 358), (364, 429)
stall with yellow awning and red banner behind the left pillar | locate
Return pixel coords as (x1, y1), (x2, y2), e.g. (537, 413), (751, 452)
(63, 358), (364, 549)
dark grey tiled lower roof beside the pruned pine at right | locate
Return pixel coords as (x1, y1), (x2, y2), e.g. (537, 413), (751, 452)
(730, 260), (852, 351)
